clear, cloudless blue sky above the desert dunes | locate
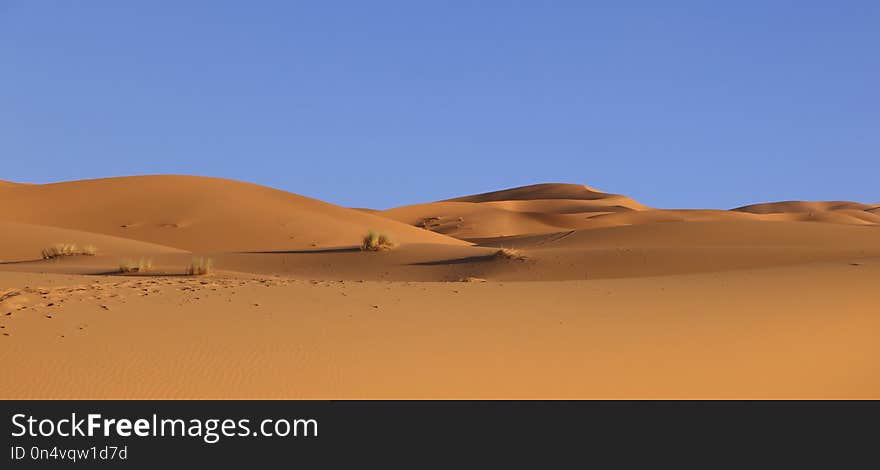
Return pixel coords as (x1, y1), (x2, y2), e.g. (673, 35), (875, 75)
(0, 0), (880, 208)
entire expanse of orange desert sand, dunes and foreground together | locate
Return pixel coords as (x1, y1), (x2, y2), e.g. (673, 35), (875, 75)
(0, 176), (880, 399)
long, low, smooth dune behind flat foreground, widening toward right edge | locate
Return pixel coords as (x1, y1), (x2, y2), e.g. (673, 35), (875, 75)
(194, 219), (880, 281)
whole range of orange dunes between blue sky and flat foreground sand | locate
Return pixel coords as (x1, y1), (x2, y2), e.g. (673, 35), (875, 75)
(0, 176), (880, 281)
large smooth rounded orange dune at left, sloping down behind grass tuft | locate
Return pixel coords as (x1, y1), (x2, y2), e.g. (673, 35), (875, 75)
(0, 176), (466, 252)
